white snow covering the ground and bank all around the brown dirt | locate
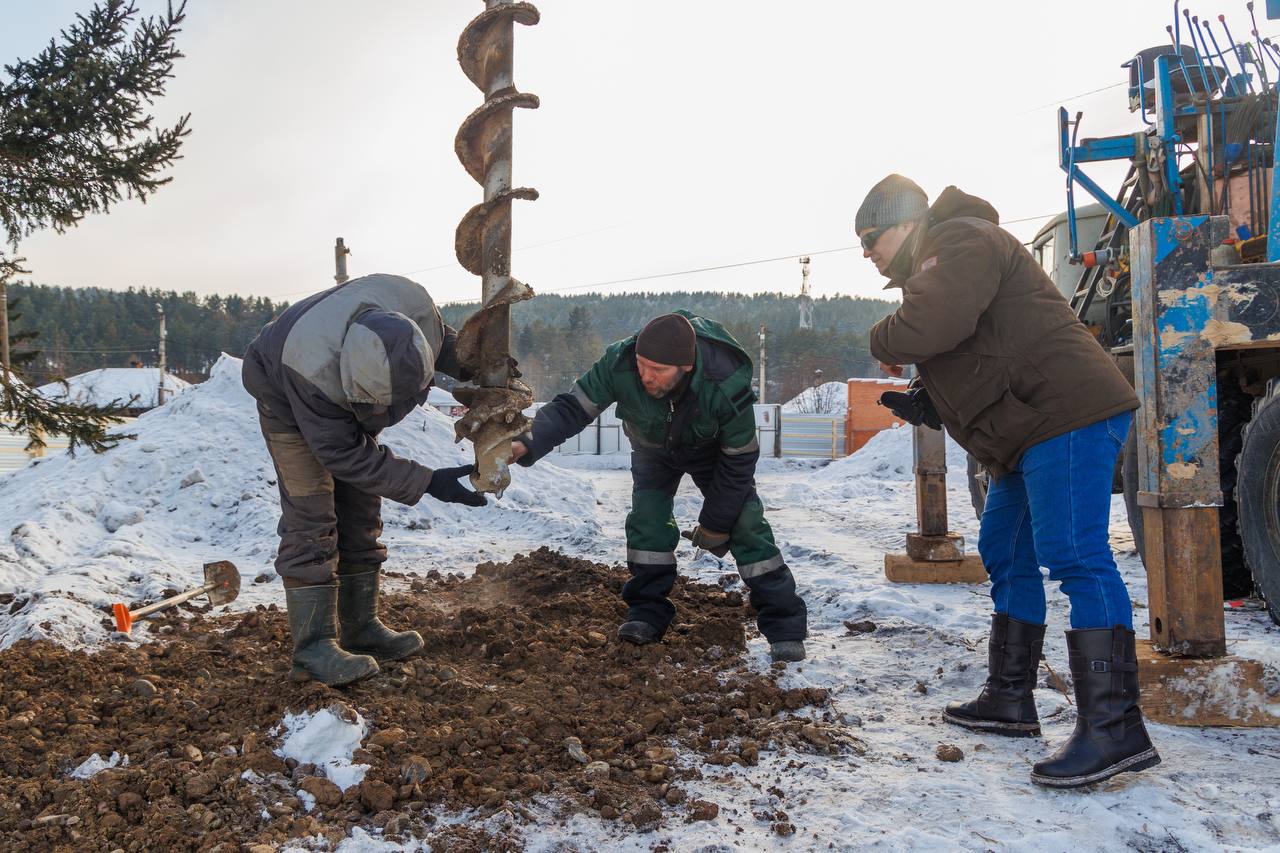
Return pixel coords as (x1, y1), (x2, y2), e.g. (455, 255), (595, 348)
(0, 350), (1280, 853)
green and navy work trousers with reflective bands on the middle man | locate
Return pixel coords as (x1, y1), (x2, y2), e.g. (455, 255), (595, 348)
(622, 451), (808, 643)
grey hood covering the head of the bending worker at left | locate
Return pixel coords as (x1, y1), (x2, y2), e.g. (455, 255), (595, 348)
(339, 309), (435, 406)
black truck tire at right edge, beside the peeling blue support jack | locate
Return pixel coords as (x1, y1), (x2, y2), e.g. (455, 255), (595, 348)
(1224, 379), (1280, 625)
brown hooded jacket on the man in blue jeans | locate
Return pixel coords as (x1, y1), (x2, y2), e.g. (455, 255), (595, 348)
(870, 187), (1138, 478)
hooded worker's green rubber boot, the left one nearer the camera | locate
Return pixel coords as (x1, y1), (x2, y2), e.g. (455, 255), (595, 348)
(284, 583), (378, 686)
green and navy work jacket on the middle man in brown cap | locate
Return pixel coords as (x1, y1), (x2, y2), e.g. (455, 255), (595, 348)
(520, 311), (760, 533)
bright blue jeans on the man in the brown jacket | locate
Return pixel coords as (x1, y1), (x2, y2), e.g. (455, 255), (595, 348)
(978, 412), (1133, 629)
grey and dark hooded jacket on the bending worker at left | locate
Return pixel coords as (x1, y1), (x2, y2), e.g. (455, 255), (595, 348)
(241, 274), (460, 505)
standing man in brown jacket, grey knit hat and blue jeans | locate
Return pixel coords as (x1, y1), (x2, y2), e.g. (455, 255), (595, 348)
(855, 174), (1160, 788)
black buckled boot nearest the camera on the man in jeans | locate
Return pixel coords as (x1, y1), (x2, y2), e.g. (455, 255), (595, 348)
(1032, 625), (1160, 788)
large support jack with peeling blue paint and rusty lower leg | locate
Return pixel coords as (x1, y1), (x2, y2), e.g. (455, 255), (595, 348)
(1130, 216), (1280, 726)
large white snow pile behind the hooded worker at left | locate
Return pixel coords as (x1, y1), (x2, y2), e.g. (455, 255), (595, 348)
(0, 356), (596, 648)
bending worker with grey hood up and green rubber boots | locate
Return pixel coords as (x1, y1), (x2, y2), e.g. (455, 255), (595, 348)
(242, 275), (485, 685)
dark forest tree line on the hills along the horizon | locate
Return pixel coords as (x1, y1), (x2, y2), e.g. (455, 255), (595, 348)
(9, 283), (895, 402)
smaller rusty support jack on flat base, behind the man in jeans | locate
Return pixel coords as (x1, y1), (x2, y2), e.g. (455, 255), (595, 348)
(884, 425), (987, 584)
